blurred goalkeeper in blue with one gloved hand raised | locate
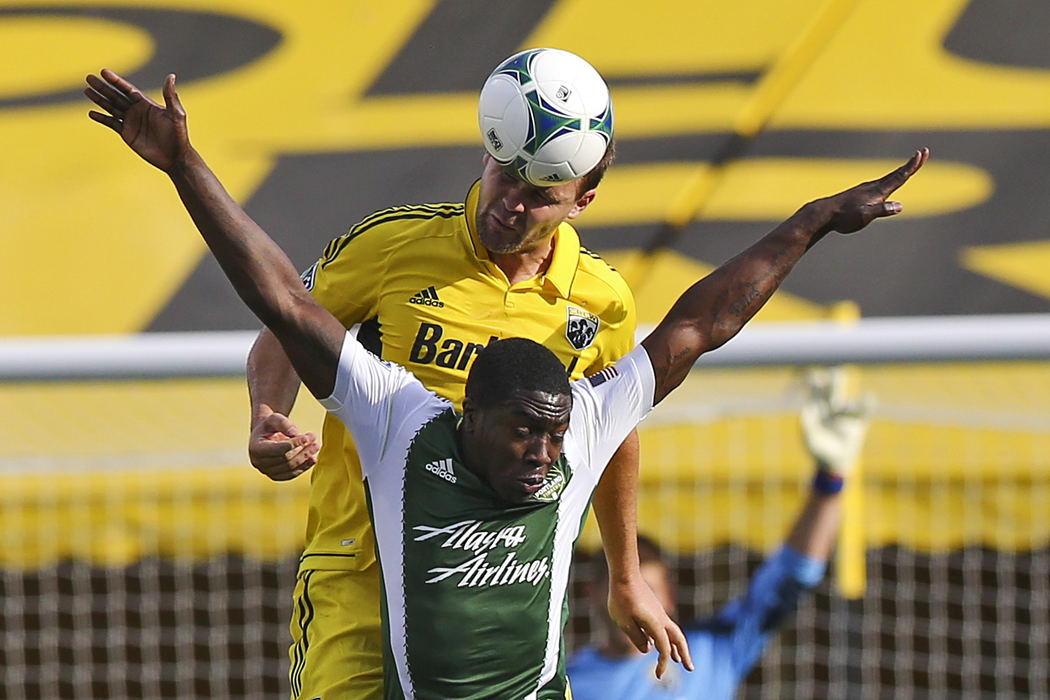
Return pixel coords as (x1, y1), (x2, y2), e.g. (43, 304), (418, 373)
(568, 370), (870, 700)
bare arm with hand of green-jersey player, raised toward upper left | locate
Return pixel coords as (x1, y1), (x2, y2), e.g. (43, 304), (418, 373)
(84, 70), (345, 397)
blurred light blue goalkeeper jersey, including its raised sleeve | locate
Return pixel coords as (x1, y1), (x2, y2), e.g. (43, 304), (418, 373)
(568, 546), (825, 700)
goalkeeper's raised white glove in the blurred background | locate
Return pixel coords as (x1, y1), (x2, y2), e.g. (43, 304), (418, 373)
(801, 367), (875, 479)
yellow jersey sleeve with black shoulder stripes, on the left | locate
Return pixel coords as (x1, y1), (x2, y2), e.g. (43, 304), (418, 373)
(302, 213), (395, 328)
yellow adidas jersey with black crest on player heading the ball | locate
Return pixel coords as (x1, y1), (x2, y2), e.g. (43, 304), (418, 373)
(301, 183), (635, 569)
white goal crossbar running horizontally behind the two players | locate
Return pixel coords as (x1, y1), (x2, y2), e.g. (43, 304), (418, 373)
(0, 314), (1050, 381)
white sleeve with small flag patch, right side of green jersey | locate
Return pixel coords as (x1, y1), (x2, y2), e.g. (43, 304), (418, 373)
(569, 345), (656, 473)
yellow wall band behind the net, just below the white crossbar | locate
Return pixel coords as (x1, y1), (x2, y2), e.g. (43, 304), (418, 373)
(0, 363), (1050, 569)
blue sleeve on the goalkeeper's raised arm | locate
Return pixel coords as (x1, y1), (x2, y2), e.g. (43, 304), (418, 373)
(689, 546), (826, 680)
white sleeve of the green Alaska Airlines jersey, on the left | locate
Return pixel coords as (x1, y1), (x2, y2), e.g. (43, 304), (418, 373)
(320, 332), (436, 475)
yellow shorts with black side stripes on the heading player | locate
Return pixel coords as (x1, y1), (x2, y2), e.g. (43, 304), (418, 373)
(288, 566), (383, 700)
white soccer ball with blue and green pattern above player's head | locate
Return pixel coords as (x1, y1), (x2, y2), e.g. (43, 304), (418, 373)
(478, 48), (612, 187)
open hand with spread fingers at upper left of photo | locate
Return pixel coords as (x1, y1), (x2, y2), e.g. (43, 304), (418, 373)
(84, 68), (190, 172)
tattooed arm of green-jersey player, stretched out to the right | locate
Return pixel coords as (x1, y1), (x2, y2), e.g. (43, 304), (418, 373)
(642, 148), (929, 404)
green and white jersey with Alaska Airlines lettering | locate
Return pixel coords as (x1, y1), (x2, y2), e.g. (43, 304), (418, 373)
(322, 335), (653, 700)
